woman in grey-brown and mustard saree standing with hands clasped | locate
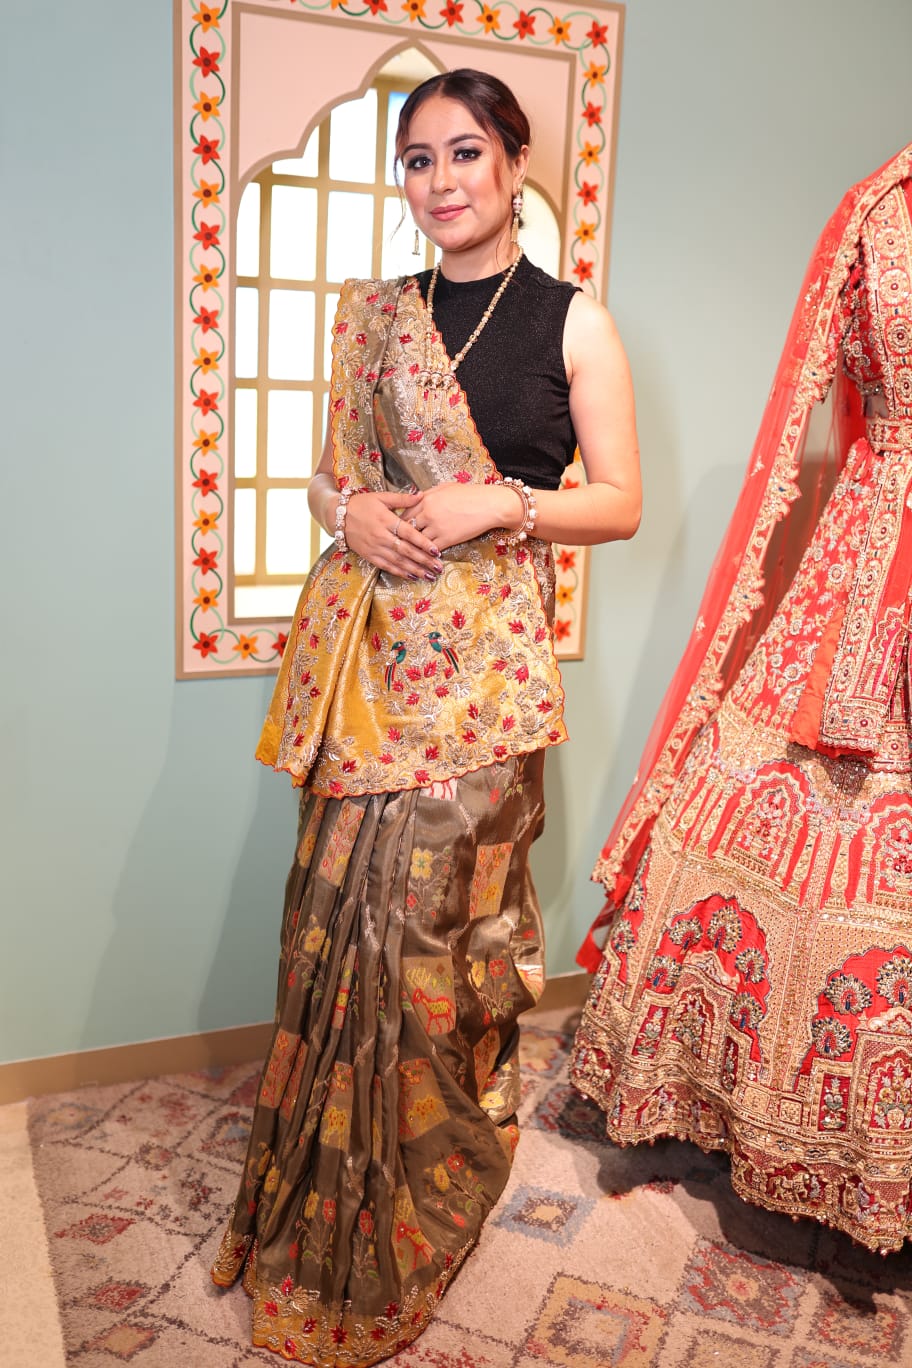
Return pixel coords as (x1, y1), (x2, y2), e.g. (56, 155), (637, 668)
(213, 71), (640, 1365)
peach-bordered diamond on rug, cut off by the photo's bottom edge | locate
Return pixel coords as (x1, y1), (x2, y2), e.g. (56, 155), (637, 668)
(524, 1274), (667, 1368)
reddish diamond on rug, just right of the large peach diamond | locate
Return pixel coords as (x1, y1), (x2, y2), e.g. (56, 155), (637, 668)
(681, 1239), (807, 1335)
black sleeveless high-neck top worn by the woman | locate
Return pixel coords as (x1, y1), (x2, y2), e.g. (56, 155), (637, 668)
(417, 256), (577, 490)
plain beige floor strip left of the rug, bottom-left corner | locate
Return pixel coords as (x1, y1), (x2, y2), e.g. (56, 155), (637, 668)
(0, 1103), (66, 1368)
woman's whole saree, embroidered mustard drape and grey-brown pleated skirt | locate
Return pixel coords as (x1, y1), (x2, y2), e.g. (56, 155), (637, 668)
(212, 280), (566, 1365)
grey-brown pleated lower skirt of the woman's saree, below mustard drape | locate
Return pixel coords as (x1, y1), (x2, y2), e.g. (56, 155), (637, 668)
(213, 751), (544, 1365)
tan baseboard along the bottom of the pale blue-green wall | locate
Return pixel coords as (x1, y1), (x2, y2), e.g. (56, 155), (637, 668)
(0, 974), (589, 1105)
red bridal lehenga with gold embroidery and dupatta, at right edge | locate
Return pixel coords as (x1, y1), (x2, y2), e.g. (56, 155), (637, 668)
(573, 148), (912, 1250)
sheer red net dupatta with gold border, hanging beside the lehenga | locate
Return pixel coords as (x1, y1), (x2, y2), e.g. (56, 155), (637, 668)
(577, 145), (912, 971)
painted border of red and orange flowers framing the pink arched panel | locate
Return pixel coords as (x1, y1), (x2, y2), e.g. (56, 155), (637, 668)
(175, 0), (622, 679)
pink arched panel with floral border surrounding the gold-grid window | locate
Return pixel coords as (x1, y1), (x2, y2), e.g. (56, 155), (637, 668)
(175, 0), (623, 679)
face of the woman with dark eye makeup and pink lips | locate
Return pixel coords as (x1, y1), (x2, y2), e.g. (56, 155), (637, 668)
(402, 96), (528, 275)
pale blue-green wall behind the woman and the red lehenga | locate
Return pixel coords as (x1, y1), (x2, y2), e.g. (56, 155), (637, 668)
(0, 0), (912, 1062)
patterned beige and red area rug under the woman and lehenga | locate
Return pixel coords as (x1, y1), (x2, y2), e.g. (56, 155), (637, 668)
(30, 1014), (912, 1368)
